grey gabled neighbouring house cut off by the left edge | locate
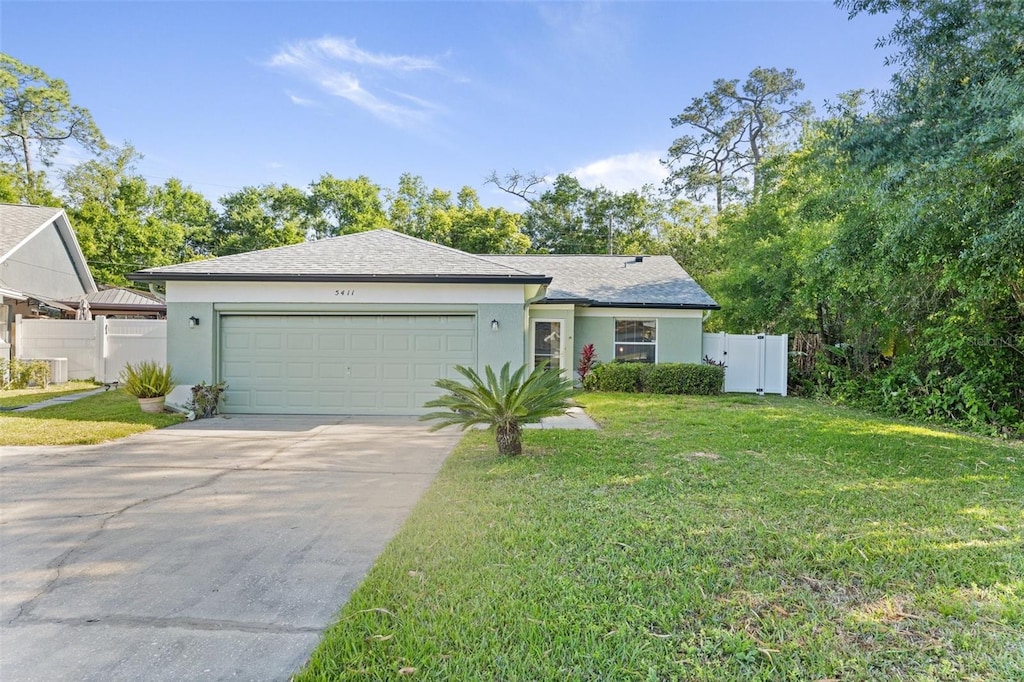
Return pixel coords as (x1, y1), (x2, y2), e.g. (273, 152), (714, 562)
(0, 204), (96, 343)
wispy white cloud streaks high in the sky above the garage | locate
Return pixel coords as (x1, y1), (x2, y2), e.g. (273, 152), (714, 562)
(266, 37), (443, 127)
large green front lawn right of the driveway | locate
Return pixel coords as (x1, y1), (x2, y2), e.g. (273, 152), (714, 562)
(296, 394), (1024, 682)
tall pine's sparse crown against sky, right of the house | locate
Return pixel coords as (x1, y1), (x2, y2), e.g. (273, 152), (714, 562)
(663, 68), (813, 212)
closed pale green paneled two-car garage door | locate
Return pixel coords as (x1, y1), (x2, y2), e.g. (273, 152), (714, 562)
(220, 315), (476, 415)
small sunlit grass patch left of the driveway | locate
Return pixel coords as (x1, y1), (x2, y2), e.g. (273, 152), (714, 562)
(0, 389), (184, 445)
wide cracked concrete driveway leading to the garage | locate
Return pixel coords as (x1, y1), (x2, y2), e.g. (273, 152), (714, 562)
(0, 416), (459, 682)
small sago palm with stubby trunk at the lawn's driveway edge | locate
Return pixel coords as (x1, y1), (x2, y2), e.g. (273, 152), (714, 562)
(420, 363), (572, 455)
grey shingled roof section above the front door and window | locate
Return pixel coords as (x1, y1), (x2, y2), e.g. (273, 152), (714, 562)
(487, 255), (720, 309)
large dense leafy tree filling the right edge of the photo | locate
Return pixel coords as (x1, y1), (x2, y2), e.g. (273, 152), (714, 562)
(837, 0), (1024, 430)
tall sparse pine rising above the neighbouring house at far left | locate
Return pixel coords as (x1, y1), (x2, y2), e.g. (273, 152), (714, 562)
(0, 53), (106, 203)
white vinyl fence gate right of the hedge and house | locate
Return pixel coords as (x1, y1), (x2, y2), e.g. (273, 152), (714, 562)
(703, 332), (790, 395)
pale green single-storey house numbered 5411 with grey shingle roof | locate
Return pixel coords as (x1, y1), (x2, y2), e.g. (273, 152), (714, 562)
(129, 229), (719, 415)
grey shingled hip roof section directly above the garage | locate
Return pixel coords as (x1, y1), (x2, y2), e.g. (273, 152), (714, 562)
(136, 229), (550, 284)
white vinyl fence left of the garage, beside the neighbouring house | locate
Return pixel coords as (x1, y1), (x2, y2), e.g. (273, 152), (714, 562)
(14, 315), (167, 382)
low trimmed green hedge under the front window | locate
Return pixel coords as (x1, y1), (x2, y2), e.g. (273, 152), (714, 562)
(584, 363), (725, 395)
